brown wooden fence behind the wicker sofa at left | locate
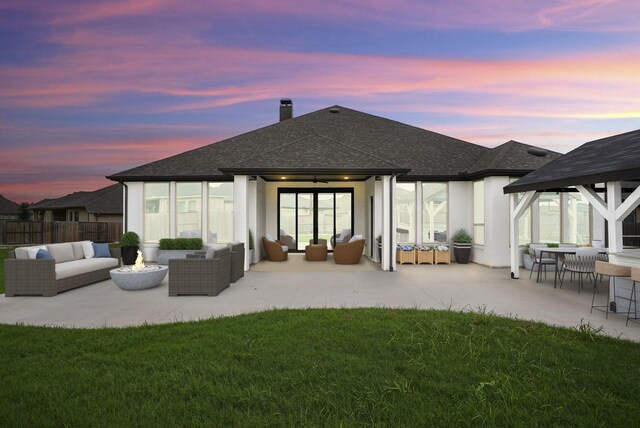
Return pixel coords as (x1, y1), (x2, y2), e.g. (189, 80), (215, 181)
(0, 220), (122, 245)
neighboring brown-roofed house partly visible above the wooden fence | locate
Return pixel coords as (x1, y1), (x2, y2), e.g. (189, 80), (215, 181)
(29, 184), (123, 223)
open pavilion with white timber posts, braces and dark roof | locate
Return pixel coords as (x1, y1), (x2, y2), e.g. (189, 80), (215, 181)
(504, 130), (640, 278)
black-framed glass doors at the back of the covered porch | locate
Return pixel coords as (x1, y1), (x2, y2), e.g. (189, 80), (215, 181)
(278, 188), (353, 251)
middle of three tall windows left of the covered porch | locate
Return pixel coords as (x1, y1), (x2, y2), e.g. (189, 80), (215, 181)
(176, 183), (202, 238)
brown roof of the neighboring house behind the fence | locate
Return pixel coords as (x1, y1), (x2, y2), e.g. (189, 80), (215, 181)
(29, 184), (122, 214)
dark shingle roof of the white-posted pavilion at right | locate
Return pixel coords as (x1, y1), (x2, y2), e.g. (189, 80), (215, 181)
(504, 129), (640, 193)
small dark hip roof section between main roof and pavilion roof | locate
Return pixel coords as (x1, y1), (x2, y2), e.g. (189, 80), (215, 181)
(468, 140), (562, 176)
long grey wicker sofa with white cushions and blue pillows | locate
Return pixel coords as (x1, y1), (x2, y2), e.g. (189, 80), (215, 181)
(4, 241), (120, 297)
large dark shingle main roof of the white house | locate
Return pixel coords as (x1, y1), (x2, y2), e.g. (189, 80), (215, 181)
(108, 106), (560, 181)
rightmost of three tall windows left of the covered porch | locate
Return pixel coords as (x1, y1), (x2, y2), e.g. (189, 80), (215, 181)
(207, 183), (234, 243)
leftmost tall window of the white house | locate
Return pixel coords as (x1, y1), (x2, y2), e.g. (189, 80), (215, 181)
(144, 183), (169, 242)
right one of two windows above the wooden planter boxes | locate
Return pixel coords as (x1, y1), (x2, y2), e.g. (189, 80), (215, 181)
(422, 183), (449, 242)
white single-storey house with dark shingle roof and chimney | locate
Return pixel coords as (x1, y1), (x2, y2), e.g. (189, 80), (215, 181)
(108, 100), (591, 270)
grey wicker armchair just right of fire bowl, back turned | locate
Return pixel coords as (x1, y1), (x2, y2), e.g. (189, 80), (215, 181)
(169, 248), (231, 296)
